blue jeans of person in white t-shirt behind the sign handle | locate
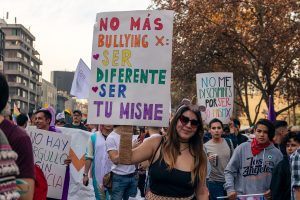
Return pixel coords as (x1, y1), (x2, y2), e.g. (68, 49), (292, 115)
(111, 173), (138, 200)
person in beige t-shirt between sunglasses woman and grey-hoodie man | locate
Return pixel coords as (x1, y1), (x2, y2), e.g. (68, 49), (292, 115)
(204, 118), (234, 200)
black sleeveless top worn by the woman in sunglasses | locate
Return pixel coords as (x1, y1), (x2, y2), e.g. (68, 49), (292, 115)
(149, 145), (195, 197)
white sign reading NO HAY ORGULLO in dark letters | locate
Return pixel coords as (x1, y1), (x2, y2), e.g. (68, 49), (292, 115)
(26, 127), (71, 199)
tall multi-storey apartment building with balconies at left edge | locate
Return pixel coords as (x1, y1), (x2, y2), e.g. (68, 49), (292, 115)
(0, 19), (42, 113)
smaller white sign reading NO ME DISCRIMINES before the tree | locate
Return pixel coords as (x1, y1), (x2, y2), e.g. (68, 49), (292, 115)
(196, 72), (234, 124)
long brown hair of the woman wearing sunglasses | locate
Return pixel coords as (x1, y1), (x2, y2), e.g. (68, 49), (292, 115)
(162, 105), (207, 184)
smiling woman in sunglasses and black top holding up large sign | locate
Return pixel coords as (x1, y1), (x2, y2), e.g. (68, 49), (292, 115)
(116, 100), (208, 200)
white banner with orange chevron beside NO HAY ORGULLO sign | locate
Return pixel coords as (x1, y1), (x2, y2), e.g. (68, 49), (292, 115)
(57, 127), (95, 200)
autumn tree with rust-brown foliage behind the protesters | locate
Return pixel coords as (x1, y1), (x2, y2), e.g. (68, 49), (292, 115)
(152, 0), (300, 124)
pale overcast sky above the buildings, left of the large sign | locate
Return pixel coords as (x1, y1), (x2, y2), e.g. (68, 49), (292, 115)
(0, 0), (151, 81)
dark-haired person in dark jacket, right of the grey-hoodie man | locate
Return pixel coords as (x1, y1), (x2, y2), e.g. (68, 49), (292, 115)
(270, 132), (300, 200)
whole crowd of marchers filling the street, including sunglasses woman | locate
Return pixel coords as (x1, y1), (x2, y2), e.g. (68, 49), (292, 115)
(0, 74), (300, 200)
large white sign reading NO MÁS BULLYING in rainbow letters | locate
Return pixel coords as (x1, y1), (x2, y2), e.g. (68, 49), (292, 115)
(88, 10), (173, 126)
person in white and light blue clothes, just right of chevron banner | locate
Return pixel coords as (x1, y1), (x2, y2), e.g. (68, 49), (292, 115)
(83, 125), (113, 200)
